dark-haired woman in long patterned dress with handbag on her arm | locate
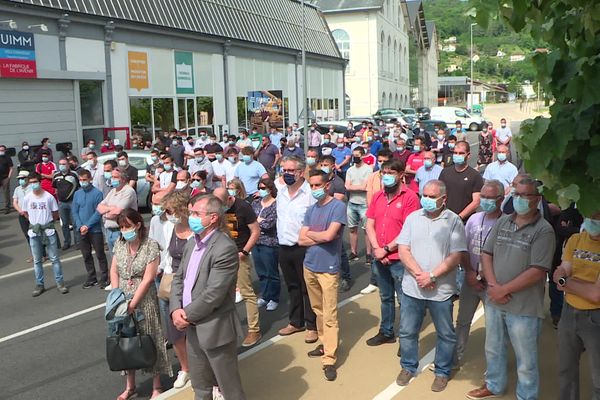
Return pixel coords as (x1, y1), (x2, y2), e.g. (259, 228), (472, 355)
(110, 208), (173, 400)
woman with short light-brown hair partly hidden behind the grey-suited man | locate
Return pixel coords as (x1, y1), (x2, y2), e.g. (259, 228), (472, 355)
(158, 191), (194, 389)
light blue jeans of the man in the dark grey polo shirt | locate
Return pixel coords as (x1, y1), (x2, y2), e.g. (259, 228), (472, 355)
(485, 301), (542, 400)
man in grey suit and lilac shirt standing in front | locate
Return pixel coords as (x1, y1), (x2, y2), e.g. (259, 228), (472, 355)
(170, 195), (246, 400)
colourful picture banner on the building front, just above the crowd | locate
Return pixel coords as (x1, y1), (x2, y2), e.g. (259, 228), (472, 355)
(248, 90), (284, 133)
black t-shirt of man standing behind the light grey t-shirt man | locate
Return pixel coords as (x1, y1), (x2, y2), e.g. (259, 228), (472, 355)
(440, 166), (483, 214)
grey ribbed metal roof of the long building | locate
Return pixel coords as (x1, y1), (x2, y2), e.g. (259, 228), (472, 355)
(9, 0), (341, 59)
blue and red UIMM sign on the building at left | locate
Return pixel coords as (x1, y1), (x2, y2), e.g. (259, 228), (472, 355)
(0, 30), (37, 78)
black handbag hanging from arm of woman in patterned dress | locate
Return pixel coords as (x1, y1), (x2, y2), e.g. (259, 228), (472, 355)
(106, 315), (156, 371)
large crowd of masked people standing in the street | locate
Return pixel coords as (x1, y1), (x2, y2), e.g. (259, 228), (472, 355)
(0, 119), (600, 400)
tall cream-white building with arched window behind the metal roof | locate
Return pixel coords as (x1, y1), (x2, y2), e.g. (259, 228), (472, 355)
(318, 0), (412, 115)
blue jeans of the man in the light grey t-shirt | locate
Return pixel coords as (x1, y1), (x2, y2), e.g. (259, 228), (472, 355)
(399, 294), (456, 378)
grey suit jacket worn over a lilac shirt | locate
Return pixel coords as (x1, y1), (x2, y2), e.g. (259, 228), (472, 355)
(169, 230), (242, 349)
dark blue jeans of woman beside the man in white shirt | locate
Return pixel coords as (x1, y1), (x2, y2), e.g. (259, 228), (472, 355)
(252, 244), (281, 303)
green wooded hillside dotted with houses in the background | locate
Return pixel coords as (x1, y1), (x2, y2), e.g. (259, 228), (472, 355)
(423, 0), (543, 84)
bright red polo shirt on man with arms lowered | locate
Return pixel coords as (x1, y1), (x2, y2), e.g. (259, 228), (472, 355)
(367, 185), (421, 261)
